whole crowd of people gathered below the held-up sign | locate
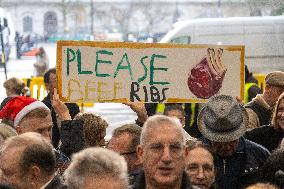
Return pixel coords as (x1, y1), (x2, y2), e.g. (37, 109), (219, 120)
(0, 68), (284, 189)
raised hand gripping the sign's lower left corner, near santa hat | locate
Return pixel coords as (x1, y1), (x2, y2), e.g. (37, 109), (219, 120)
(51, 88), (71, 121)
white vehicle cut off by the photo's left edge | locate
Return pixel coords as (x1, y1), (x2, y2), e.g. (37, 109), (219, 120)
(0, 8), (15, 66)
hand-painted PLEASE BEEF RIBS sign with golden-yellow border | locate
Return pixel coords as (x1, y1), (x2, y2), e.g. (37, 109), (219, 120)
(57, 41), (244, 102)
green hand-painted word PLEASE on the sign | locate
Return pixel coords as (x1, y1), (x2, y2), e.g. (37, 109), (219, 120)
(66, 48), (169, 85)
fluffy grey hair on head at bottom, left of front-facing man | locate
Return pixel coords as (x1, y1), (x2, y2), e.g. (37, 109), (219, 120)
(64, 147), (128, 189)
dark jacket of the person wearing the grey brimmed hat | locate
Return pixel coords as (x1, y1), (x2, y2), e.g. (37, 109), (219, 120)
(212, 137), (270, 189)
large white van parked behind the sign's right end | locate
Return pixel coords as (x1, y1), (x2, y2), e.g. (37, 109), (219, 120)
(160, 16), (284, 73)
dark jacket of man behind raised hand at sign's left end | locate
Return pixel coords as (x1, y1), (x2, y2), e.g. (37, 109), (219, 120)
(42, 94), (80, 148)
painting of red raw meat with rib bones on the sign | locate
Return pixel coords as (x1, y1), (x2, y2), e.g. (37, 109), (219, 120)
(187, 48), (227, 99)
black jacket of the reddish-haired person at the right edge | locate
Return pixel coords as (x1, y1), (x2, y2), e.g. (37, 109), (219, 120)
(244, 125), (284, 152)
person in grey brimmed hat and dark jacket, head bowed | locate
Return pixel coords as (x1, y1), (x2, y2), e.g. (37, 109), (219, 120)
(197, 95), (270, 189)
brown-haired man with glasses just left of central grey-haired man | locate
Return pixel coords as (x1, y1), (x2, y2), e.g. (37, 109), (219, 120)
(107, 124), (142, 185)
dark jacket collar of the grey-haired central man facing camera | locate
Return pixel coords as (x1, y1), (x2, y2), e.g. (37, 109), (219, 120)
(132, 171), (193, 189)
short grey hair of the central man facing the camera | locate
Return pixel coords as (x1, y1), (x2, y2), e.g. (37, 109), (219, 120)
(140, 115), (185, 146)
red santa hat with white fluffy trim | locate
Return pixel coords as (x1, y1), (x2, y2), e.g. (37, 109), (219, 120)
(0, 96), (49, 127)
